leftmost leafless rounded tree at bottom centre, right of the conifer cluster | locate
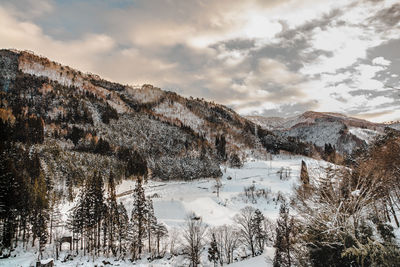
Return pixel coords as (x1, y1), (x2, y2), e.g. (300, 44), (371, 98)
(183, 216), (207, 267)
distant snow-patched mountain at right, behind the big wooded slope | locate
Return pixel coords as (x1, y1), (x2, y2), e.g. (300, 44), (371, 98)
(247, 111), (387, 154)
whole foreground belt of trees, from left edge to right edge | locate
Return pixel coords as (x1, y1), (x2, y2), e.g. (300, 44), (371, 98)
(0, 130), (400, 266)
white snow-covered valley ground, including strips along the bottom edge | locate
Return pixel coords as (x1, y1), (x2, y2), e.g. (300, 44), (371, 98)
(0, 155), (326, 266)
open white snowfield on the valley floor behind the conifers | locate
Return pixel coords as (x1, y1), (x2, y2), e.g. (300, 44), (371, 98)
(117, 156), (312, 227)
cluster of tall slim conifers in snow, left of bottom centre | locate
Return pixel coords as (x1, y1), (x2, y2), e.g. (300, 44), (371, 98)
(68, 173), (168, 260)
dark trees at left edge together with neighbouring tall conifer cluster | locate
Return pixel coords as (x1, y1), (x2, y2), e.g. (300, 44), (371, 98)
(0, 151), (168, 260)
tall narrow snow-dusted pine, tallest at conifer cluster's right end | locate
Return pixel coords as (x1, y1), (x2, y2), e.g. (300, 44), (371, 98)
(131, 176), (148, 259)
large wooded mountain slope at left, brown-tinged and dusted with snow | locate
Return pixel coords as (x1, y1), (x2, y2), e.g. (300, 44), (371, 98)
(0, 50), (309, 197)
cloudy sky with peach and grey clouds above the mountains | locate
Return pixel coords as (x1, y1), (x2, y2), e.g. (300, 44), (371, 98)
(0, 0), (400, 121)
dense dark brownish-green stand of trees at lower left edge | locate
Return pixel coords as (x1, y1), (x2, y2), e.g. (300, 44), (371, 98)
(0, 145), (51, 254)
